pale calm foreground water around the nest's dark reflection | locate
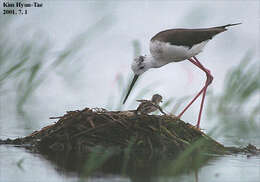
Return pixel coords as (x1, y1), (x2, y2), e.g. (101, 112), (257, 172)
(0, 142), (260, 182)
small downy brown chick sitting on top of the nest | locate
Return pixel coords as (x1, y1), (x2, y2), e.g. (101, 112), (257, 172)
(136, 94), (166, 114)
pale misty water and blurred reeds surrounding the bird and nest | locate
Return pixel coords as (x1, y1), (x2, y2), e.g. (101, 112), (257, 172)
(0, 0), (260, 182)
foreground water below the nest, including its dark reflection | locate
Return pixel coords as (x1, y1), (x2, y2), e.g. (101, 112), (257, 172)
(0, 145), (260, 182)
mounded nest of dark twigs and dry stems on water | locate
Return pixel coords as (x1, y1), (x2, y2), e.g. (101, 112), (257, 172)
(7, 108), (224, 157)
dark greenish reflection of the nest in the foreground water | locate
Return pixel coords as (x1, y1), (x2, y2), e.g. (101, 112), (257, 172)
(35, 144), (216, 182)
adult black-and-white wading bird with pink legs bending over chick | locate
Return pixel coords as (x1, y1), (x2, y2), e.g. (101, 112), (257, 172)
(123, 23), (241, 128)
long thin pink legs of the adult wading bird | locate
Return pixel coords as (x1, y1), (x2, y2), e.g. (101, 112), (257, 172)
(178, 56), (213, 128)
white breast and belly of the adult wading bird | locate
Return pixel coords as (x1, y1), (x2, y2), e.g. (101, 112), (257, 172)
(150, 40), (208, 64)
